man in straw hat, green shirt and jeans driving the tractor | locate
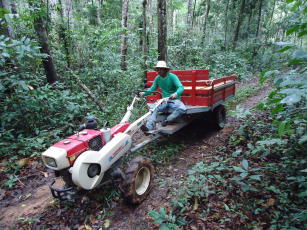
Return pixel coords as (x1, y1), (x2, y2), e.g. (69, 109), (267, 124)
(140, 61), (186, 131)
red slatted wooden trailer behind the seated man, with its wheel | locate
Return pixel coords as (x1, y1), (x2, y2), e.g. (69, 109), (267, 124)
(145, 69), (237, 134)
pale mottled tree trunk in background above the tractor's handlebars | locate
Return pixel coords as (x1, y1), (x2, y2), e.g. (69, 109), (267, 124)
(120, 0), (129, 70)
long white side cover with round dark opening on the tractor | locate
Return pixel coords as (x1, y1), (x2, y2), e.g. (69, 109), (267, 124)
(70, 133), (132, 190)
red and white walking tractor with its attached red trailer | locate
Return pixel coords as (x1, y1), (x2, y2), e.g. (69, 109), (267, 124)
(42, 70), (237, 204)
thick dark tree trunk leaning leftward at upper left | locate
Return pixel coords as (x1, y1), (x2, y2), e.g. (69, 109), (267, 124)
(28, 0), (58, 84)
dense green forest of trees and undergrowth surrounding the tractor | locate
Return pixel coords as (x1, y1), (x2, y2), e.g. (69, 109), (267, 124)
(0, 0), (307, 230)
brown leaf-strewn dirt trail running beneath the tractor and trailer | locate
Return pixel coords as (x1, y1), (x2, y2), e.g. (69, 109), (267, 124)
(0, 81), (269, 230)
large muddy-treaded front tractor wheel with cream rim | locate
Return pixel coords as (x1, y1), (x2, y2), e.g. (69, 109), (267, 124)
(121, 156), (154, 204)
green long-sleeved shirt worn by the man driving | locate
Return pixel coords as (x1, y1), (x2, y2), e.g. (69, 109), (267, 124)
(145, 73), (184, 100)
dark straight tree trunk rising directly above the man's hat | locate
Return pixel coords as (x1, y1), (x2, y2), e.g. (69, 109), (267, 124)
(157, 0), (167, 61)
